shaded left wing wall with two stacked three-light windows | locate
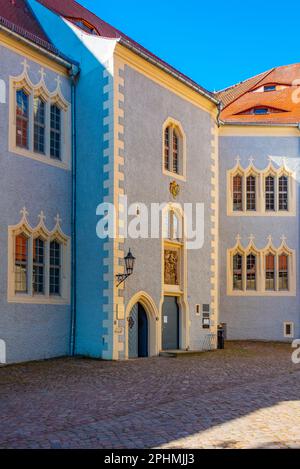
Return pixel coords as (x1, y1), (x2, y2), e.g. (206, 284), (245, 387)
(0, 2), (72, 363)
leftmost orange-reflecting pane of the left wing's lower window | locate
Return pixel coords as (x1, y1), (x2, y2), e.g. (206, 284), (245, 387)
(15, 234), (28, 293)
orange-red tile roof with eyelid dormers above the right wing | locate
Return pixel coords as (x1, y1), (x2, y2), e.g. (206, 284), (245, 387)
(217, 63), (300, 124)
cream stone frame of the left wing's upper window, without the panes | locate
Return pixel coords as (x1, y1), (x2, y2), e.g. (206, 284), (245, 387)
(9, 59), (71, 169)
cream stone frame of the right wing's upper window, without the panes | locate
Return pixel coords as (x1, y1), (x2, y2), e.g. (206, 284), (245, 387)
(227, 158), (296, 217)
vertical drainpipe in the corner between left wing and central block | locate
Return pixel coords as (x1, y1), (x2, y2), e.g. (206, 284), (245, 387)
(69, 66), (80, 357)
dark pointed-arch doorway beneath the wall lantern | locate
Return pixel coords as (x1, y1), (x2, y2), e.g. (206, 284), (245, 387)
(128, 303), (149, 358)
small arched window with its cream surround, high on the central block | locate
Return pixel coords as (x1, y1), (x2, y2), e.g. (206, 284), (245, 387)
(162, 117), (186, 181)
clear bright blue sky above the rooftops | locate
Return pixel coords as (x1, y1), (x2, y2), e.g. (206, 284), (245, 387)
(78, 0), (300, 91)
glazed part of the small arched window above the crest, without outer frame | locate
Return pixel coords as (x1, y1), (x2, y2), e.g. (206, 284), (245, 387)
(164, 124), (183, 175)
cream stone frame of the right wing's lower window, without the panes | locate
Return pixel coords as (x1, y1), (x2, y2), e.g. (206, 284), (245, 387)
(227, 235), (297, 296)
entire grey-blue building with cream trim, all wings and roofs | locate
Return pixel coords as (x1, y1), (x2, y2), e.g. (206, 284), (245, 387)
(0, 0), (300, 363)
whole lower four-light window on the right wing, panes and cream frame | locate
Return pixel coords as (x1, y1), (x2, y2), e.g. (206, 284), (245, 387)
(227, 235), (296, 296)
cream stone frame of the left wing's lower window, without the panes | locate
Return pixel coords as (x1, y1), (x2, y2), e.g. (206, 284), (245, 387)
(7, 208), (71, 305)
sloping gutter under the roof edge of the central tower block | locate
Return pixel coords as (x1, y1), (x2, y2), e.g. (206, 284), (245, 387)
(119, 37), (220, 105)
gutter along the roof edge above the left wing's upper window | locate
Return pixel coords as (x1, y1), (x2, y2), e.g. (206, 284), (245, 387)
(0, 17), (79, 70)
